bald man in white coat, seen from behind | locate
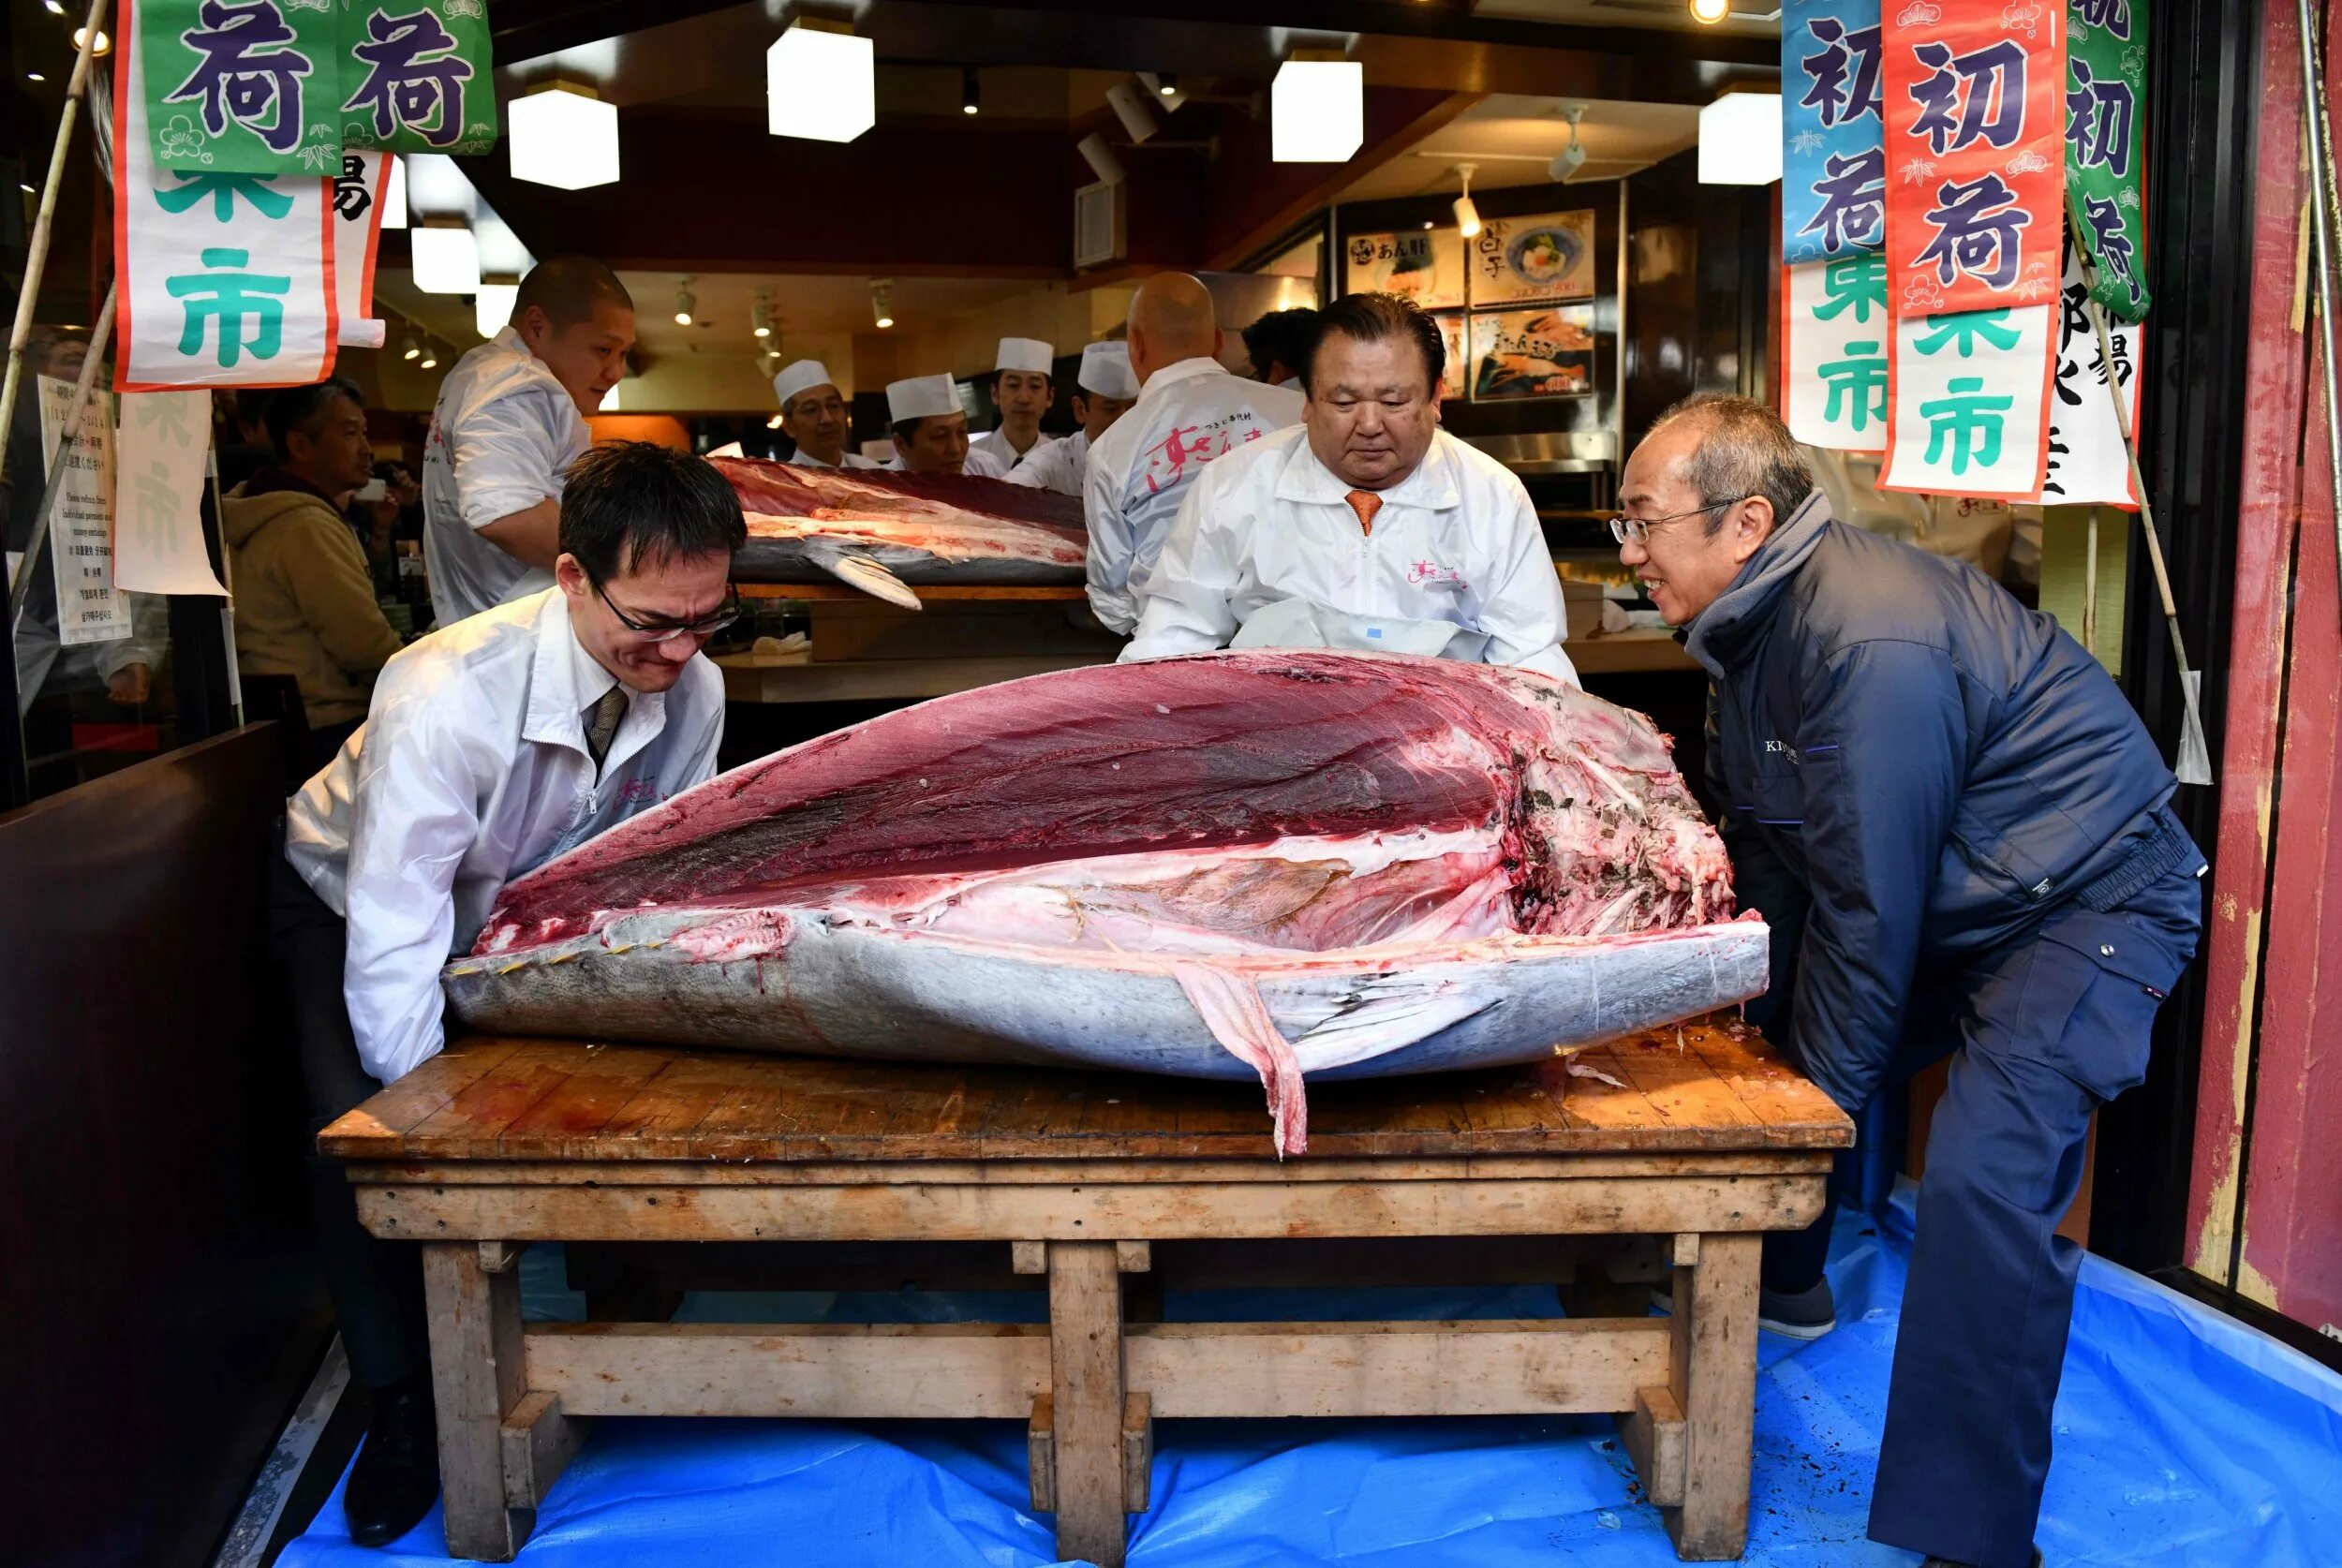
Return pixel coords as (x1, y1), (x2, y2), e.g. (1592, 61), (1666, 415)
(1082, 272), (1302, 637)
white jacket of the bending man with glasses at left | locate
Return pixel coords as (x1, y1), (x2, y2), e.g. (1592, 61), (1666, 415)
(286, 587), (724, 1084)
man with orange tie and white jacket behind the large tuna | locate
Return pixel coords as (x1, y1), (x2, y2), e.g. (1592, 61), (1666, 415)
(1122, 295), (1577, 684)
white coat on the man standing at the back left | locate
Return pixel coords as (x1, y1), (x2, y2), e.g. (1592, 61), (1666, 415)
(424, 325), (593, 625)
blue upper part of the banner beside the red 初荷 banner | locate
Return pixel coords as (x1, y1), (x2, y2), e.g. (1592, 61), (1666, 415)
(1780, 0), (1888, 264)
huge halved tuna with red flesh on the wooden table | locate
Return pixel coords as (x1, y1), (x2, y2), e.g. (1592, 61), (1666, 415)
(445, 651), (1766, 1151)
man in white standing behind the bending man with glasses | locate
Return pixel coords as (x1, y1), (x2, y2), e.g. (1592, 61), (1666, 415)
(424, 255), (635, 628)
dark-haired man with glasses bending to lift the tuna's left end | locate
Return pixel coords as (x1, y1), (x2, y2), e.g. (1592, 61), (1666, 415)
(272, 442), (748, 1545)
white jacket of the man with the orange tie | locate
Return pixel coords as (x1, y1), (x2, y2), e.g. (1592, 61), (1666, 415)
(1124, 425), (1579, 684)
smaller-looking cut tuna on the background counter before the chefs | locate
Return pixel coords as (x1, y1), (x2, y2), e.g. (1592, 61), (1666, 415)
(710, 456), (1089, 611)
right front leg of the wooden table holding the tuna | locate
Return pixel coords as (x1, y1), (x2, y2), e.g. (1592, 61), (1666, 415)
(1663, 1234), (1764, 1563)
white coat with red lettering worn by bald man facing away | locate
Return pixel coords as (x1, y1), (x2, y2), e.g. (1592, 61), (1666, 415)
(1082, 358), (1302, 637)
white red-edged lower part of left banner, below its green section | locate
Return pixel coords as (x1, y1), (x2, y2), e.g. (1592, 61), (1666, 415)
(115, 5), (340, 391)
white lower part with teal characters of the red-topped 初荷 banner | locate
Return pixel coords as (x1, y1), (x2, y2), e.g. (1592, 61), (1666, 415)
(1878, 304), (2056, 501)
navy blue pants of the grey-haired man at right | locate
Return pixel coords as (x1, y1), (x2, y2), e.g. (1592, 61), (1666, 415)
(1872, 865), (2204, 1568)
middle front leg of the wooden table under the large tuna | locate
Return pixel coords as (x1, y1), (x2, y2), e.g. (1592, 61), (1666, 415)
(1049, 1240), (1124, 1568)
